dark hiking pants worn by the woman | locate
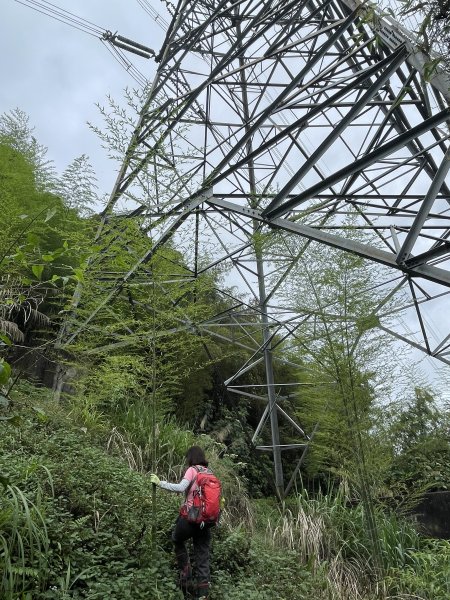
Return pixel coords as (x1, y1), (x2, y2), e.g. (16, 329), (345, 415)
(172, 517), (211, 591)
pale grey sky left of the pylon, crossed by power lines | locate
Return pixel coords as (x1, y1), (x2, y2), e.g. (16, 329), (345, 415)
(0, 0), (167, 193)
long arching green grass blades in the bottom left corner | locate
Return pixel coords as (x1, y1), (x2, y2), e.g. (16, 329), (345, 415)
(0, 485), (49, 600)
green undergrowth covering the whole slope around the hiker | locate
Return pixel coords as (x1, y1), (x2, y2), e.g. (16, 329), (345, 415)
(0, 386), (450, 600)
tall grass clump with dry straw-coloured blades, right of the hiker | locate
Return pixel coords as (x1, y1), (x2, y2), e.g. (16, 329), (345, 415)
(266, 491), (428, 600)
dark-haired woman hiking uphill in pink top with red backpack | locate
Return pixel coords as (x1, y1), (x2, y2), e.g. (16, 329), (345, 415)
(150, 446), (220, 600)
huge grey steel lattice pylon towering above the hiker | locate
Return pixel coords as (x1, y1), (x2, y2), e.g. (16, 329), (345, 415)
(65, 0), (450, 495)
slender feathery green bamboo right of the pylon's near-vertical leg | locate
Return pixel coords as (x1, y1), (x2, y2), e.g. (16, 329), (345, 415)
(280, 233), (400, 487)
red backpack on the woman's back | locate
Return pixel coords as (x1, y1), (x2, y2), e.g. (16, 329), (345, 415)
(180, 466), (222, 525)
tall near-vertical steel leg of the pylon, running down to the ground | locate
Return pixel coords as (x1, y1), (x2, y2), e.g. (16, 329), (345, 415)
(236, 15), (284, 498)
